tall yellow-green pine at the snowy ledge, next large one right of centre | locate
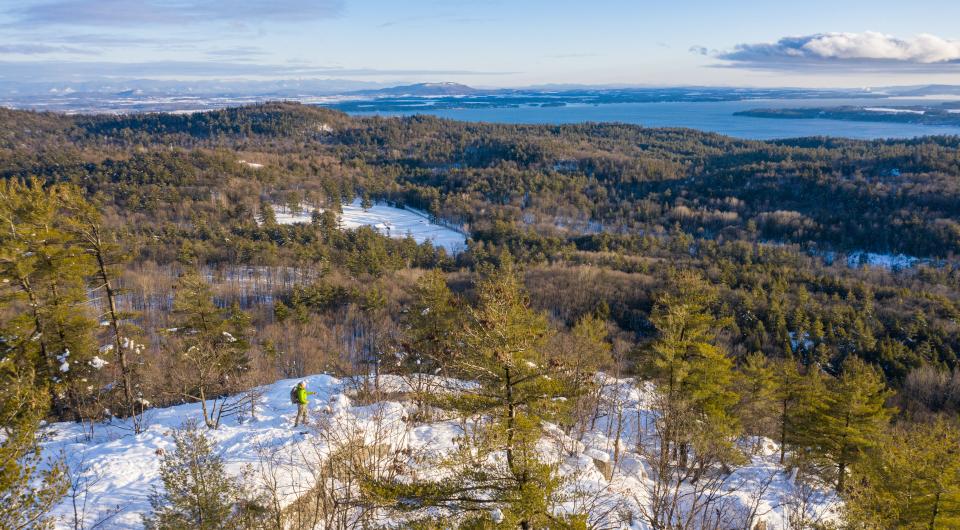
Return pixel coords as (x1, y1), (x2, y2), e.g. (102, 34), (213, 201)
(638, 272), (743, 528)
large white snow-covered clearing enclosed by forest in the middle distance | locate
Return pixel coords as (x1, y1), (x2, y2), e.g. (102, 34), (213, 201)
(274, 199), (467, 254)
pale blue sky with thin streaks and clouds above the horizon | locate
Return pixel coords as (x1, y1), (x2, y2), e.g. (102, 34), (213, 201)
(0, 0), (960, 87)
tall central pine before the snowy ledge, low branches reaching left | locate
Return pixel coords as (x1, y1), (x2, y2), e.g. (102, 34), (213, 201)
(368, 259), (577, 529)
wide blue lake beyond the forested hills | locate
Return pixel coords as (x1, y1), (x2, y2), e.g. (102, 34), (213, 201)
(351, 98), (960, 140)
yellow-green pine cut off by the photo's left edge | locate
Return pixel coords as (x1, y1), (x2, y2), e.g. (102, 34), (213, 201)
(0, 179), (96, 420)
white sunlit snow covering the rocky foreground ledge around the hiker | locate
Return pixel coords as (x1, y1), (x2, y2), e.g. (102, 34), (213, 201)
(43, 375), (838, 530)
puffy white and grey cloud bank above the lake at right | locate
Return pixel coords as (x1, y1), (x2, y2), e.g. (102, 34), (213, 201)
(716, 31), (960, 72)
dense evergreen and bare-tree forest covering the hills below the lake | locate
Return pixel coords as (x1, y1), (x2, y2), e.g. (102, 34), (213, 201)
(0, 103), (960, 529)
